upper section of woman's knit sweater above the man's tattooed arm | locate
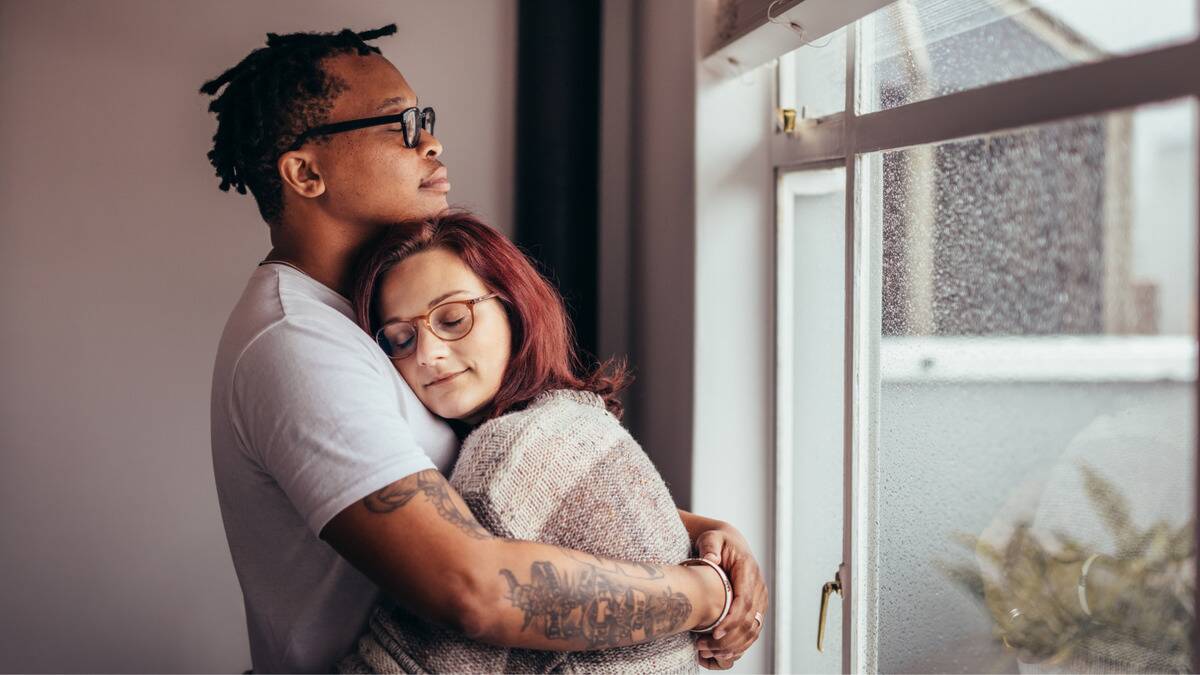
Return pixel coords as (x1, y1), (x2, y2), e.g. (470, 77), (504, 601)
(451, 396), (691, 563)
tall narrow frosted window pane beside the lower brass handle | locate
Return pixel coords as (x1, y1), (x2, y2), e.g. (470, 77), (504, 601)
(775, 167), (846, 673)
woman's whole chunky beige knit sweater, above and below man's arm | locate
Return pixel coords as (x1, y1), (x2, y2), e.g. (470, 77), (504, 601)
(338, 389), (697, 673)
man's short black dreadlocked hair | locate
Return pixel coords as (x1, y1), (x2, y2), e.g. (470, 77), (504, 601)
(200, 24), (396, 223)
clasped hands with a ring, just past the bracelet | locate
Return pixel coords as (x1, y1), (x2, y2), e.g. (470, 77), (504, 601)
(696, 522), (768, 670)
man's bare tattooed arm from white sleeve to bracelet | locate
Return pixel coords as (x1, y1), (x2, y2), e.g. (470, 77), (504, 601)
(322, 471), (725, 651)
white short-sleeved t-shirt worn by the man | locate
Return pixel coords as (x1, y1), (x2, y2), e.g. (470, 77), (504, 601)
(211, 264), (458, 673)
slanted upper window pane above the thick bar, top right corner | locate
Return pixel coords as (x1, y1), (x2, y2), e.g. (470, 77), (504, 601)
(860, 0), (1196, 112)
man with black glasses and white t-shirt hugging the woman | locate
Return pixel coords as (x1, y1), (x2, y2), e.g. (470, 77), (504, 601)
(200, 25), (767, 673)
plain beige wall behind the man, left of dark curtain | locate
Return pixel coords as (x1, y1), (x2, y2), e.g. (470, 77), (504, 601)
(0, 0), (516, 671)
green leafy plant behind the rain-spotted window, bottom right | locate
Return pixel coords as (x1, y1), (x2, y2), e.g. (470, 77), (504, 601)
(936, 465), (1195, 673)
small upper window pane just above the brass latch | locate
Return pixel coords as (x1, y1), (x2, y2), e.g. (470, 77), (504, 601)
(779, 28), (847, 119)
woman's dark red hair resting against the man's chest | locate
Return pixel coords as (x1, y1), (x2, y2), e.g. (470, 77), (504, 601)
(353, 210), (629, 418)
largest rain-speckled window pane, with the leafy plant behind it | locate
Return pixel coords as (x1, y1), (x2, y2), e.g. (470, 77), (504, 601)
(860, 100), (1198, 673)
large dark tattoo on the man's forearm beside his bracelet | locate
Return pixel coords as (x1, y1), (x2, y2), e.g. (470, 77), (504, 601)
(500, 561), (691, 649)
